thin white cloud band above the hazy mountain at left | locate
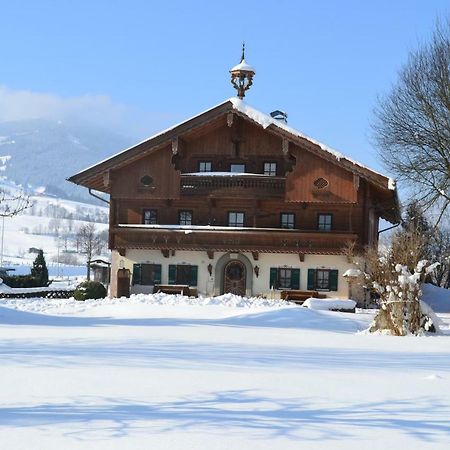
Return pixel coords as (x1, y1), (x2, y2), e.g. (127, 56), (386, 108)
(0, 86), (178, 136)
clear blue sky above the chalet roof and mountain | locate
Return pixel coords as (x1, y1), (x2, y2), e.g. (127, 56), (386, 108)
(0, 0), (450, 174)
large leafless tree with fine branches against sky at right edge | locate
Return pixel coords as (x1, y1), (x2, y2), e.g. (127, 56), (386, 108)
(373, 19), (450, 223)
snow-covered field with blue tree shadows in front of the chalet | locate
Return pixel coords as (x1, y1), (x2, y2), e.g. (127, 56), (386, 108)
(0, 294), (450, 450)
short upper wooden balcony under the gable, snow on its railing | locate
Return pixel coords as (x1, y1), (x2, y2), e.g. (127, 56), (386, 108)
(180, 172), (286, 198)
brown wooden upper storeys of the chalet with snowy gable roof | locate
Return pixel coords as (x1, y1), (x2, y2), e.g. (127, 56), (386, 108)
(69, 100), (399, 302)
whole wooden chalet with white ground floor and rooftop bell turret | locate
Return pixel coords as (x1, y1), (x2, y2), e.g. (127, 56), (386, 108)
(69, 48), (400, 298)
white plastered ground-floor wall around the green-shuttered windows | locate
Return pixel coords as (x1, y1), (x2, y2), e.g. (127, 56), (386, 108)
(111, 249), (362, 298)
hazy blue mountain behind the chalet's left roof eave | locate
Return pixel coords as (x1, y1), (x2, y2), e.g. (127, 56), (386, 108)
(0, 119), (134, 200)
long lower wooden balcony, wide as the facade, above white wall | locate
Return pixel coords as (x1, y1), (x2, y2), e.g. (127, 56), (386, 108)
(110, 225), (358, 256)
